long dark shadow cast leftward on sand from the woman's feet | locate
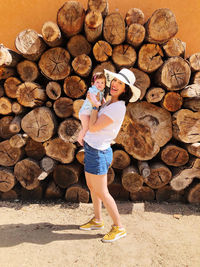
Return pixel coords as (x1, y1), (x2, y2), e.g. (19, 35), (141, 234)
(0, 222), (102, 247)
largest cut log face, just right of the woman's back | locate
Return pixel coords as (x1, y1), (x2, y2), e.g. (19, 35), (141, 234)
(115, 102), (172, 160)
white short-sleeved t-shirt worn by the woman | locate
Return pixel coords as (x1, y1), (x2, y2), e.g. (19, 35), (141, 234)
(84, 100), (126, 150)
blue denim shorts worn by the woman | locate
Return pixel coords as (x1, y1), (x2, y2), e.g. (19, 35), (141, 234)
(84, 142), (113, 175)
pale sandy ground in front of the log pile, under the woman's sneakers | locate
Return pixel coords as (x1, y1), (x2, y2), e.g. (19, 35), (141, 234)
(0, 202), (200, 267)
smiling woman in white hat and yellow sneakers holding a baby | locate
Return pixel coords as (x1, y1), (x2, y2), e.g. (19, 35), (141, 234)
(79, 68), (141, 242)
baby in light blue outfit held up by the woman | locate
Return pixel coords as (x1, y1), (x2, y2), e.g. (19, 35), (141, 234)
(77, 72), (106, 146)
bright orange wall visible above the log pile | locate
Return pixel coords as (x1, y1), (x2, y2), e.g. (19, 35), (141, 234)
(0, 0), (200, 55)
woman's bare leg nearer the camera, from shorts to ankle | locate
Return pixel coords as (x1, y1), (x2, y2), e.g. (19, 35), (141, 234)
(85, 172), (123, 227)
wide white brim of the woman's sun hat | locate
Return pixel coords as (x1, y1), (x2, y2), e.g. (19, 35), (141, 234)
(104, 69), (141, 102)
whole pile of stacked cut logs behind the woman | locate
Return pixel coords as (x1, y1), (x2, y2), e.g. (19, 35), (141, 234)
(0, 0), (200, 203)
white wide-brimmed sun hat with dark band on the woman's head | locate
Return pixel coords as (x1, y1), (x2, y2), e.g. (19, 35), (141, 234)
(104, 68), (141, 102)
